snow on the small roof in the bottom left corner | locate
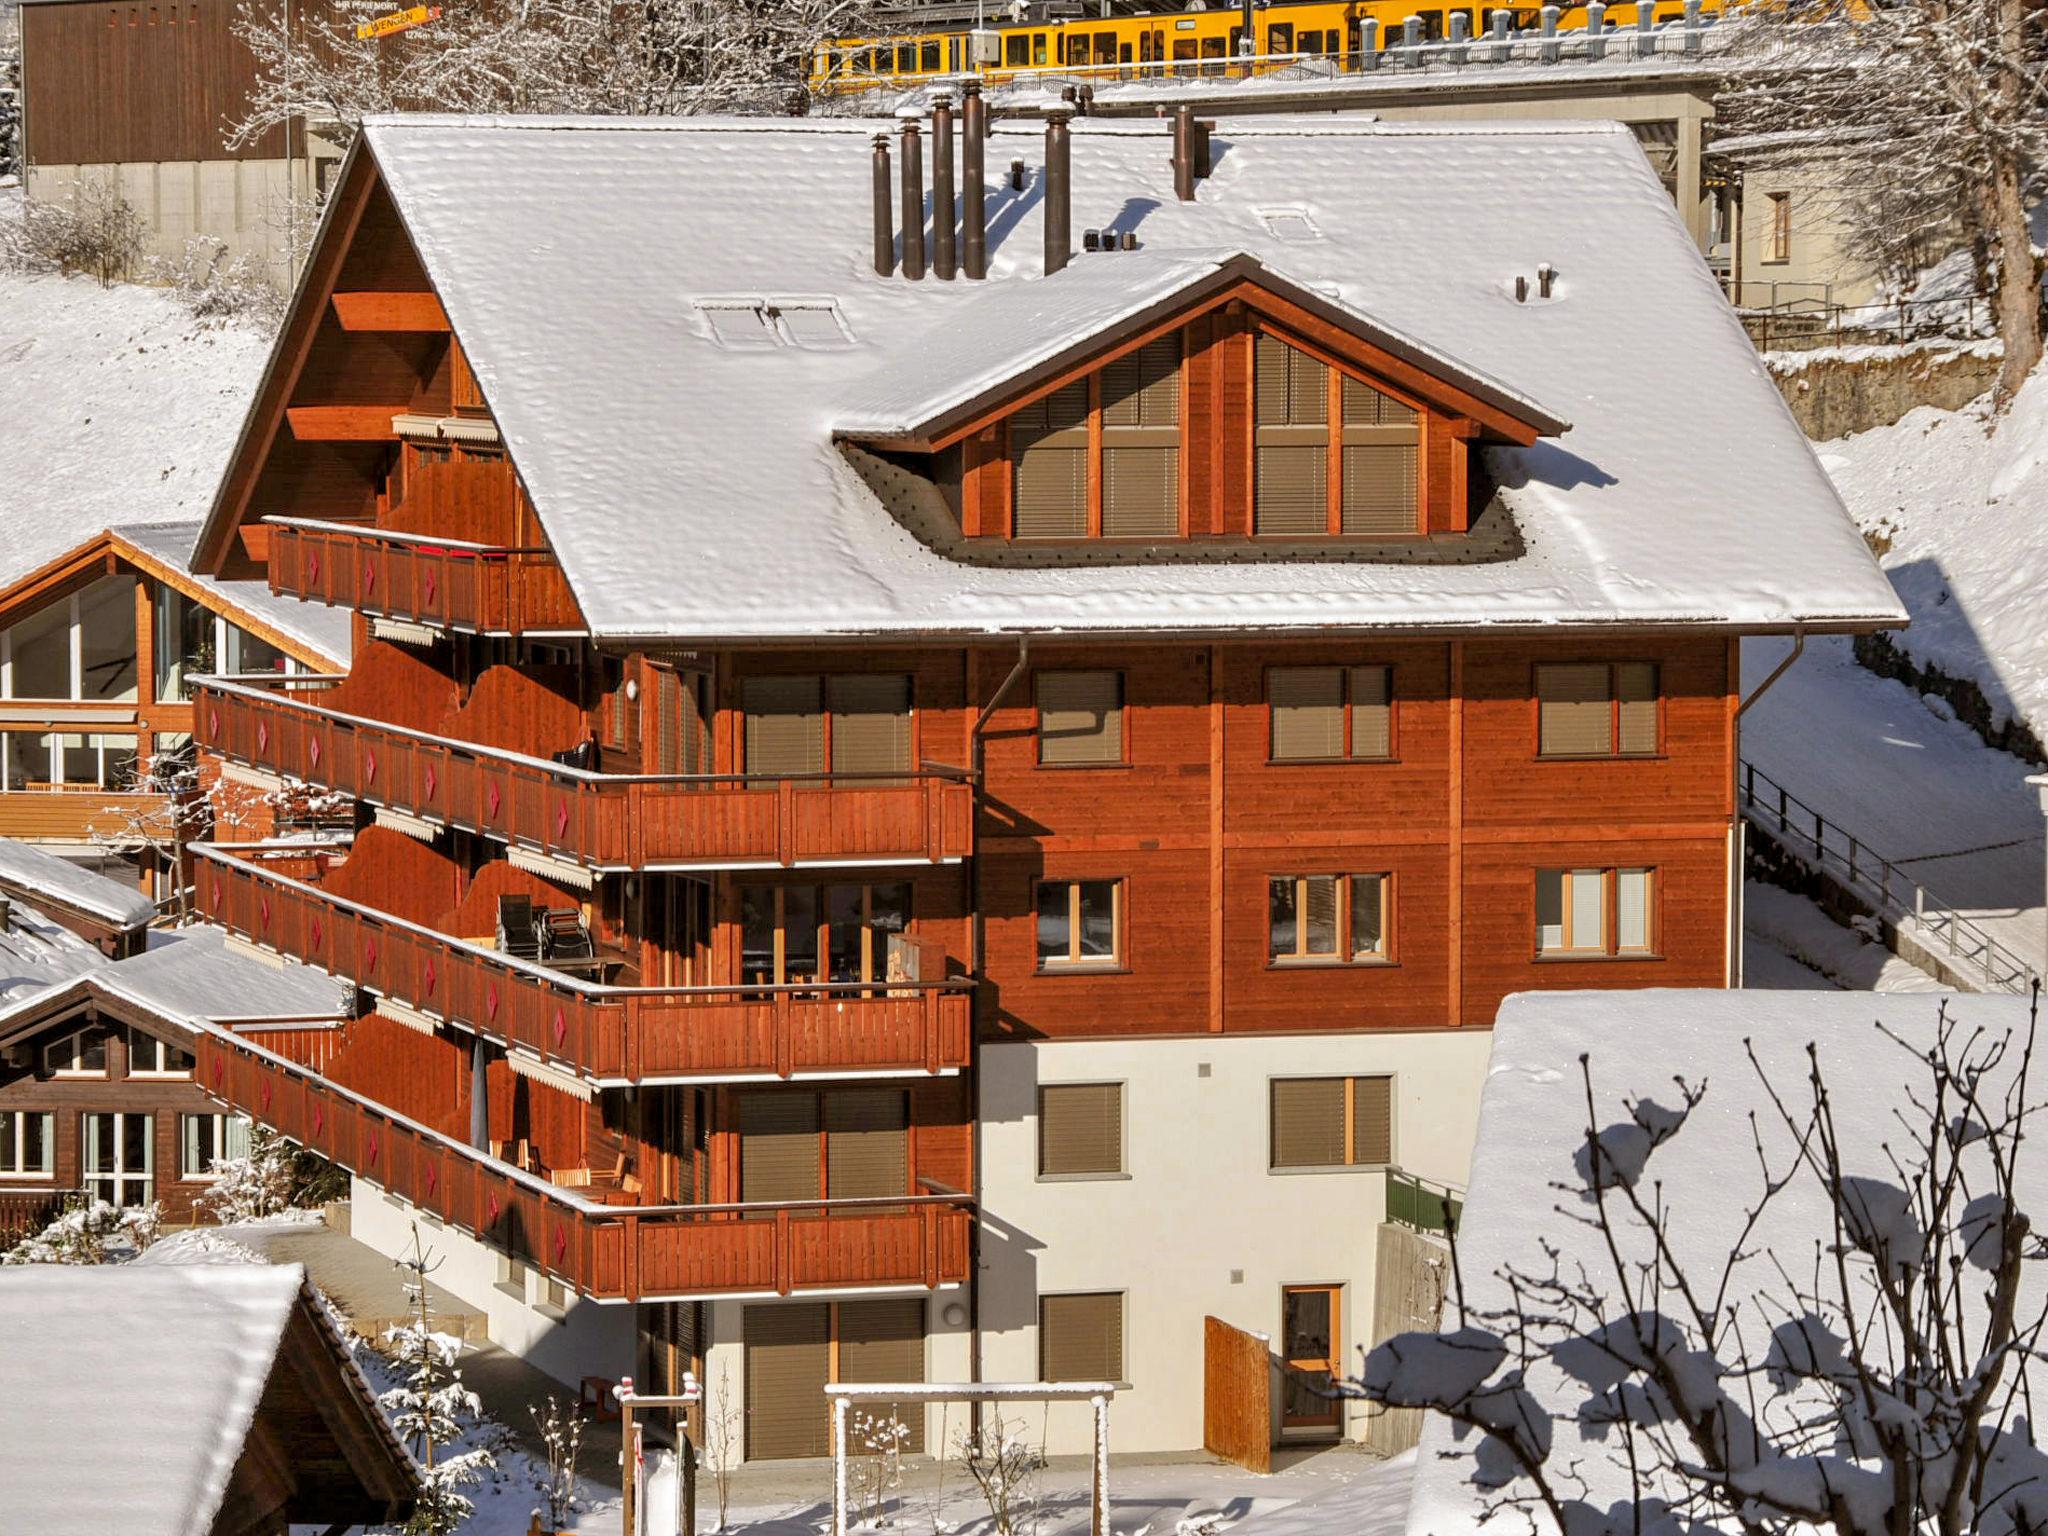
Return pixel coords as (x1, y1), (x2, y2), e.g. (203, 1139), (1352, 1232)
(0, 1264), (305, 1536)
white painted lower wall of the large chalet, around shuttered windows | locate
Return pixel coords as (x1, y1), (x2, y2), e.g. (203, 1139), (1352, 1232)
(981, 1028), (1493, 1454)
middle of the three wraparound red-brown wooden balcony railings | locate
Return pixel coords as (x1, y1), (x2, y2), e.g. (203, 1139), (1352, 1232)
(190, 844), (973, 1087)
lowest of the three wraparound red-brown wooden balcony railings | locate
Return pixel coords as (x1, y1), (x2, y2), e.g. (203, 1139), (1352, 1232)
(197, 1030), (973, 1300)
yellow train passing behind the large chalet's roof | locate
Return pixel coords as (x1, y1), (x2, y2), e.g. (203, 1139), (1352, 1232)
(811, 0), (1720, 94)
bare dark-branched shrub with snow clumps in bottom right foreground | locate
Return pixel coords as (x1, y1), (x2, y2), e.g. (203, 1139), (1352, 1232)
(1348, 993), (2048, 1536)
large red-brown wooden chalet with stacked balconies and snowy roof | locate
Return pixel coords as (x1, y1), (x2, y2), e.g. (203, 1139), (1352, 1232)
(172, 111), (1903, 1458)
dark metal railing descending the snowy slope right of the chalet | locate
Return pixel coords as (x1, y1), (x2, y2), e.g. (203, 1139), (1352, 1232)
(1739, 758), (2036, 991)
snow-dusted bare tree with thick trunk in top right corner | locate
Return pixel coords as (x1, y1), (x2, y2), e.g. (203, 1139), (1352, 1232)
(1714, 0), (2048, 406)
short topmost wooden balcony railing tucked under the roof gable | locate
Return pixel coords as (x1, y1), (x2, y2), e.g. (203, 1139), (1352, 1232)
(268, 518), (586, 635)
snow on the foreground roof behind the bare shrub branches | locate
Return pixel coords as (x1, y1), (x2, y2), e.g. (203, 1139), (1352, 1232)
(1407, 991), (2048, 1536)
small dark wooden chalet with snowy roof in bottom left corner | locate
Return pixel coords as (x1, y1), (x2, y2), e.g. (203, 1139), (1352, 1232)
(0, 1255), (420, 1536)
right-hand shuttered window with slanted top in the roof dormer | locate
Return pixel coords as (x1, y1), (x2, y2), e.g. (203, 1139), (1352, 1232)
(1253, 332), (1421, 539)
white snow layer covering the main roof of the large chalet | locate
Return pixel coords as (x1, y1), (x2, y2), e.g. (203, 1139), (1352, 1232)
(348, 117), (1901, 641)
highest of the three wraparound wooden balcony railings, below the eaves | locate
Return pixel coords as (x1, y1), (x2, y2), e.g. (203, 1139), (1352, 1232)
(193, 676), (975, 870)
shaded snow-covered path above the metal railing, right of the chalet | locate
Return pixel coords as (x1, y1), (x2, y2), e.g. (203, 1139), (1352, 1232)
(1743, 637), (2048, 965)
